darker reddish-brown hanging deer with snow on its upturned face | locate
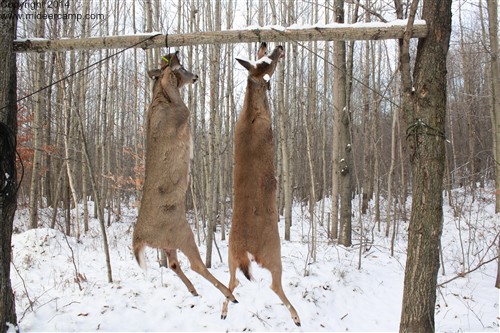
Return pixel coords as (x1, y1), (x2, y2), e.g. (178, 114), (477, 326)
(222, 43), (300, 326)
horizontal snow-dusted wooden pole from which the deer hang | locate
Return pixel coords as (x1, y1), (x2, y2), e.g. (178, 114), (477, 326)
(14, 21), (427, 52)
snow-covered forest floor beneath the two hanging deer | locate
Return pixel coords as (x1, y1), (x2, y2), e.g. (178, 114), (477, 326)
(11, 189), (500, 332)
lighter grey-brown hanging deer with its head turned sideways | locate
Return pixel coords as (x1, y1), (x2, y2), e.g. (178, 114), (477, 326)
(133, 53), (236, 301)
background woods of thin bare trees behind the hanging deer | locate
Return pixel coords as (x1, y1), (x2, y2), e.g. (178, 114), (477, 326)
(1, 0), (499, 330)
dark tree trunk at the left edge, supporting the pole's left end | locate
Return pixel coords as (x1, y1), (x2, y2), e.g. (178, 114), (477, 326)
(0, 0), (18, 331)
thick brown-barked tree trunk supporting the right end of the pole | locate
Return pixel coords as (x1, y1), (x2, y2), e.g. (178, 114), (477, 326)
(400, 0), (452, 332)
